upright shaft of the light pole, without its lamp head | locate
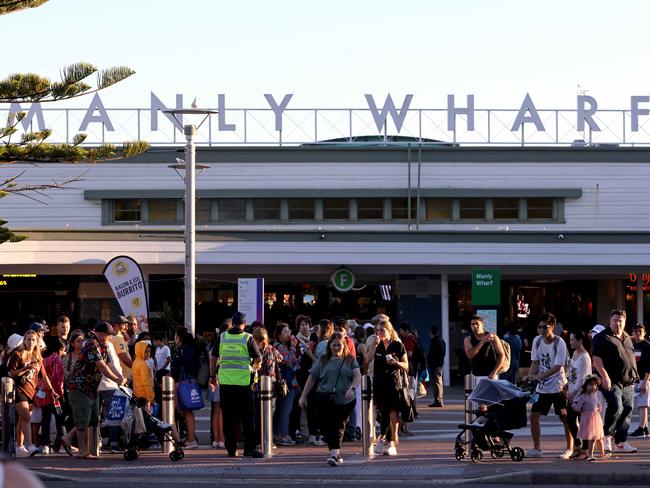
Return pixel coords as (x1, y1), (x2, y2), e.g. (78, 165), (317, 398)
(185, 125), (196, 335)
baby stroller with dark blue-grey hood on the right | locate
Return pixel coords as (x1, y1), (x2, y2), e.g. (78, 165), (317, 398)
(454, 379), (530, 463)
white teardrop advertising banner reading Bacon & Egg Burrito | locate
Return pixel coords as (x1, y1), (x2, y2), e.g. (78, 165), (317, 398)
(104, 256), (149, 332)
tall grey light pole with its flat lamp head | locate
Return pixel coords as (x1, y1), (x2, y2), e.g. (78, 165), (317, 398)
(164, 108), (217, 335)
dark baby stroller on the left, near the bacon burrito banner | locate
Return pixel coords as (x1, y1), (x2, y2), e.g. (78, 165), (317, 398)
(120, 388), (185, 461)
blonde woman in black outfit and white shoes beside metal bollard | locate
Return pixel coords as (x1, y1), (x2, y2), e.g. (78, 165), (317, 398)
(366, 320), (408, 456)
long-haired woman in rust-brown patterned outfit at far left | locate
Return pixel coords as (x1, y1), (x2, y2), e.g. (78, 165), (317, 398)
(7, 330), (52, 457)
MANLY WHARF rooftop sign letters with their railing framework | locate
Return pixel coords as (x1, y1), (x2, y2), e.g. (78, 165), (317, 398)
(0, 92), (650, 146)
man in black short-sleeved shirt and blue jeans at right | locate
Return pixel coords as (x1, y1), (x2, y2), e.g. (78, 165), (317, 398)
(592, 310), (639, 452)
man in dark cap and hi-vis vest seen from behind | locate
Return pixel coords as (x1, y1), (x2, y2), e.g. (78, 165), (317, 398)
(210, 312), (264, 458)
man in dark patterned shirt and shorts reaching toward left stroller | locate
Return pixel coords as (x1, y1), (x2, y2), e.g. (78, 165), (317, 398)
(68, 322), (126, 459)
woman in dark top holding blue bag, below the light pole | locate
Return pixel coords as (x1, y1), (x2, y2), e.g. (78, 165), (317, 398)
(171, 327), (199, 449)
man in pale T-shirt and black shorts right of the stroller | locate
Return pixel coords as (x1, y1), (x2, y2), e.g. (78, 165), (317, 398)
(526, 313), (573, 459)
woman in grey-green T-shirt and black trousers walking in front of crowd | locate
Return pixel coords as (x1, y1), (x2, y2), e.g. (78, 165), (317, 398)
(299, 334), (361, 466)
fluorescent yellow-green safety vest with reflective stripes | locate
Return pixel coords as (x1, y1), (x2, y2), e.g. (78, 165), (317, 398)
(219, 332), (253, 386)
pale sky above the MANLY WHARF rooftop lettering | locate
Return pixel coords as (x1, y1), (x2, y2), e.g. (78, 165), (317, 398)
(0, 0), (650, 108)
